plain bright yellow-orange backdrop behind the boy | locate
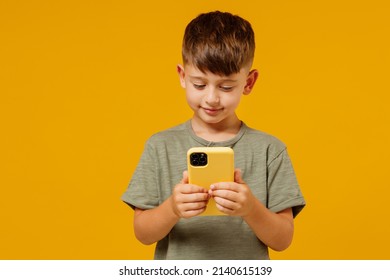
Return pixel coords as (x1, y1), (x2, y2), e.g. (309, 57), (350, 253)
(0, 0), (390, 259)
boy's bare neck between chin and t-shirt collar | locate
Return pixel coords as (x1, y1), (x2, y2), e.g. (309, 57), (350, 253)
(191, 116), (242, 142)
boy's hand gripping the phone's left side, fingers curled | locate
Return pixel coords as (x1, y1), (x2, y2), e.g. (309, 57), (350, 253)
(172, 171), (210, 218)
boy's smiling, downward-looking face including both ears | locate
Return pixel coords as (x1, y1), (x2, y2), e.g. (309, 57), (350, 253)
(177, 64), (258, 124)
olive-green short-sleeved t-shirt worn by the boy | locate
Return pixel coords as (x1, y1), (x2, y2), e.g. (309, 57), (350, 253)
(122, 121), (305, 260)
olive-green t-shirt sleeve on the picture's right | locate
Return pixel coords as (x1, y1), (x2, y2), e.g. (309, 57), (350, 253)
(267, 148), (306, 217)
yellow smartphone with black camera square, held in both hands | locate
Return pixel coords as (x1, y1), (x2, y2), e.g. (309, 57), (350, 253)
(187, 147), (234, 216)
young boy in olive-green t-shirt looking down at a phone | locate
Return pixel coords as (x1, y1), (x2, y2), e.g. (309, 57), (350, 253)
(122, 11), (305, 259)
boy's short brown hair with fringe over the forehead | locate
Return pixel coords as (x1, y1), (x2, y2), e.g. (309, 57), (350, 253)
(182, 11), (255, 76)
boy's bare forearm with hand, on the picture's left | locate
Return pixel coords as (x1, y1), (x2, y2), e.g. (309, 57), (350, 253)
(134, 172), (209, 245)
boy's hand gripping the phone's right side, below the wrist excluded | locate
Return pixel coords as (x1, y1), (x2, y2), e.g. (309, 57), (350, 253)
(209, 169), (256, 217)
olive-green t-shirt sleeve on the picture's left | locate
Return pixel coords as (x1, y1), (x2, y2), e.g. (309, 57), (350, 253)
(122, 141), (159, 209)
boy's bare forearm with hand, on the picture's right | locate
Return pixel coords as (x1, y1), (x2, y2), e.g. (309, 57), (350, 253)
(210, 170), (294, 251)
